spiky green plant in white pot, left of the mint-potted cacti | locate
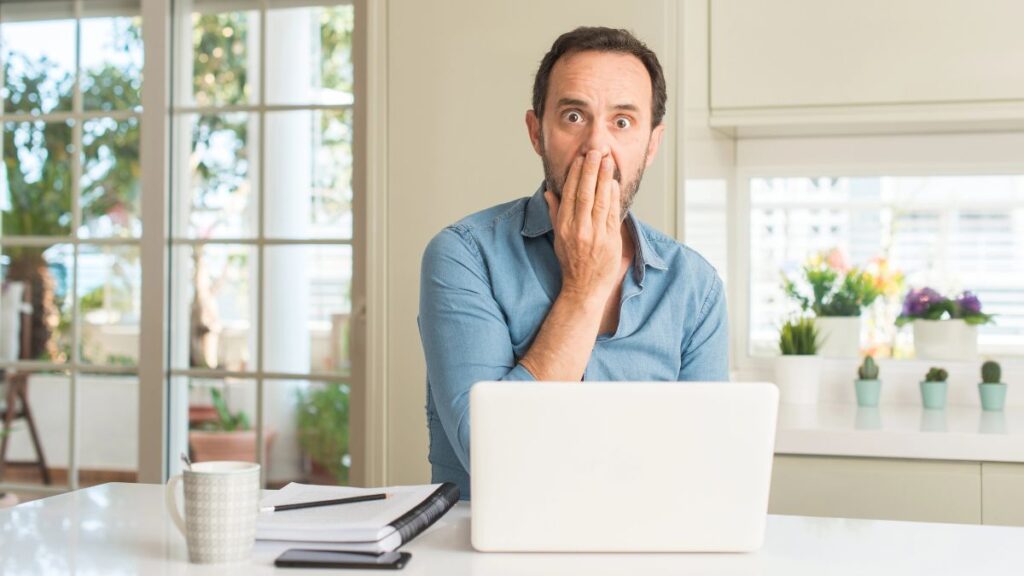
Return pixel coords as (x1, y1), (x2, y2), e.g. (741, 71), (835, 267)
(775, 317), (821, 404)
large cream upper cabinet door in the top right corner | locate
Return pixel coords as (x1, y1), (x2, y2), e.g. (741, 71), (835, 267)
(711, 0), (1024, 110)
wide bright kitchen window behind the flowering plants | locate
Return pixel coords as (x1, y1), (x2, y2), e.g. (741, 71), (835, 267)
(749, 175), (1024, 358)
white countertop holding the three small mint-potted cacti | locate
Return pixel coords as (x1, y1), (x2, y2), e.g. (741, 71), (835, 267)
(775, 404), (1024, 462)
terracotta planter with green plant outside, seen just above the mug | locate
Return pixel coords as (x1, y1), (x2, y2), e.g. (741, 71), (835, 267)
(188, 388), (276, 461)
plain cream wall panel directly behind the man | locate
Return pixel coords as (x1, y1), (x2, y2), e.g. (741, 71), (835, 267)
(386, 0), (678, 483)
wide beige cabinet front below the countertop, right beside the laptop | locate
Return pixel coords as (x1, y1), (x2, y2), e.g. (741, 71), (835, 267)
(768, 455), (981, 524)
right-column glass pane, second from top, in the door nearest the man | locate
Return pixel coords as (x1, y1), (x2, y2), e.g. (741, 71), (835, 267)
(264, 110), (352, 239)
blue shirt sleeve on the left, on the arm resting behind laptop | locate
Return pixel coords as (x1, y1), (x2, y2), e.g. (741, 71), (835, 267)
(419, 228), (534, 471)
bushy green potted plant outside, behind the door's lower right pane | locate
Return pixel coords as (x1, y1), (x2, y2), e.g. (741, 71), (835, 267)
(296, 382), (350, 484)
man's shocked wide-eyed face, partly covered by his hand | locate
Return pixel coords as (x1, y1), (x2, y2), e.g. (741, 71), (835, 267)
(526, 51), (665, 217)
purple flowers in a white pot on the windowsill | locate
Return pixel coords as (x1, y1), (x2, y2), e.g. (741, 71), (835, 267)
(896, 286), (992, 360)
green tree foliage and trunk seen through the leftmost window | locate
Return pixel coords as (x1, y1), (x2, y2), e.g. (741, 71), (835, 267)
(0, 18), (141, 362)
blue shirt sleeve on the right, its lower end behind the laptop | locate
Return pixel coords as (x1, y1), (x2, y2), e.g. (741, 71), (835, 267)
(679, 274), (729, 381)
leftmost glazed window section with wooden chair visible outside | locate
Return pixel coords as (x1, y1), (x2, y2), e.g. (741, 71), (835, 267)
(0, 1), (143, 492)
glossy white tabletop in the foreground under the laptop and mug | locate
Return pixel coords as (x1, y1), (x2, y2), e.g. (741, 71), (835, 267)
(0, 484), (1024, 576)
